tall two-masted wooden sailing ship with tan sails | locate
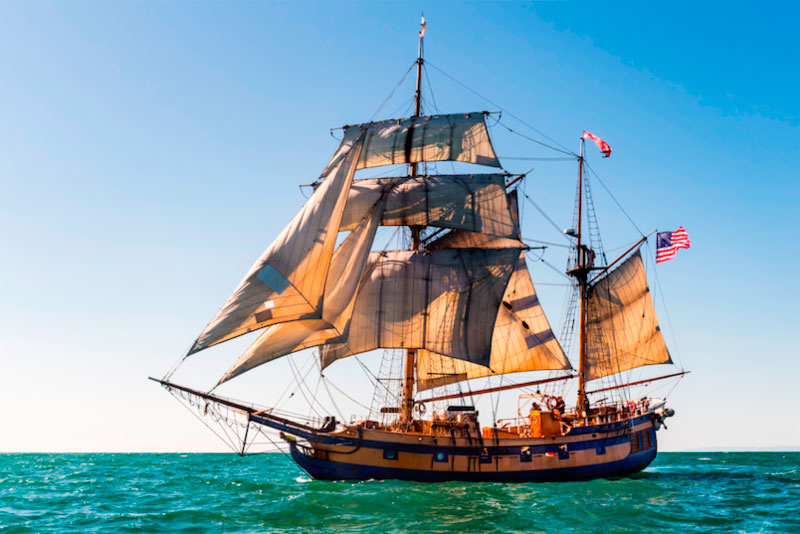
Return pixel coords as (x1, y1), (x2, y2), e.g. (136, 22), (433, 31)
(154, 21), (685, 481)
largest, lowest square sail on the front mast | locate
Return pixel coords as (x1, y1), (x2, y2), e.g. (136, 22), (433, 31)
(320, 249), (519, 367)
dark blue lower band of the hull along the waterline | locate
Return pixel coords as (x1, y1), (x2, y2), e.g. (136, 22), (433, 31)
(290, 442), (656, 482)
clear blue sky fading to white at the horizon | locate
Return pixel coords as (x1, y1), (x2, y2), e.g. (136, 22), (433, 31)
(0, 2), (800, 451)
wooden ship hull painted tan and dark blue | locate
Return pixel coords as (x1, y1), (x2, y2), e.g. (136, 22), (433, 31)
(282, 415), (658, 482)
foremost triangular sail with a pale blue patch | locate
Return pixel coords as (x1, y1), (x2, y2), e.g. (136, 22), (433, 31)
(189, 137), (363, 354)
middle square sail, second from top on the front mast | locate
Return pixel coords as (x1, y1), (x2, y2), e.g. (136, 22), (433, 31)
(340, 174), (519, 239)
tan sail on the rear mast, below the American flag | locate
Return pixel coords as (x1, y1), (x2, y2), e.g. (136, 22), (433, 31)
(584, 250), (672, 380)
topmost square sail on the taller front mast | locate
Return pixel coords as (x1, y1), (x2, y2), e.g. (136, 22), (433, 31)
(322, 112), (500, 174)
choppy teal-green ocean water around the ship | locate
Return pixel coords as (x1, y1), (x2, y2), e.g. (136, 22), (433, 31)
(0, 452), (800, 534)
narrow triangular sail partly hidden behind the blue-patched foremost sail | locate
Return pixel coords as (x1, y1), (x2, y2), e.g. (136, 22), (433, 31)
(214, 197), (385, 384)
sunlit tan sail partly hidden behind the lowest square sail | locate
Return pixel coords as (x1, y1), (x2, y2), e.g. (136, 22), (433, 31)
(417, 232), (571, 391)
